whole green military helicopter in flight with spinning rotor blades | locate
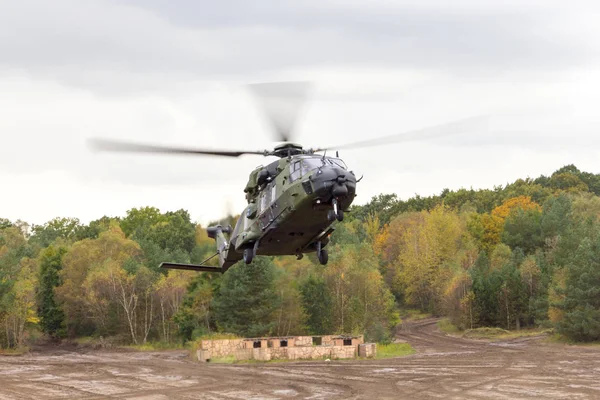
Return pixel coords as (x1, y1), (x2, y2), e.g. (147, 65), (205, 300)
(90, 82), (483, 273)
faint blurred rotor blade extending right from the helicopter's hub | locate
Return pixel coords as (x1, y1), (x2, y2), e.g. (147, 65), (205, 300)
(314, 116), (489, 152)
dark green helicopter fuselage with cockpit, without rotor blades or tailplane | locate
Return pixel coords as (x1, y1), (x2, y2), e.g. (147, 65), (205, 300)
(220, 155), (356, 270)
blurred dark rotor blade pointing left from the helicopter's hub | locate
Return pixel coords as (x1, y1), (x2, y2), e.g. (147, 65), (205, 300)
(88, 139), (266, 157)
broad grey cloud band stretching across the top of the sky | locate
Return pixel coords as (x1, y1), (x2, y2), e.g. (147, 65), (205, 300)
(0, 0), (594, 93)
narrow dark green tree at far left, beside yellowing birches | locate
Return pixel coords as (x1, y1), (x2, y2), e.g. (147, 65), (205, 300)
(37, 246), (67, 338)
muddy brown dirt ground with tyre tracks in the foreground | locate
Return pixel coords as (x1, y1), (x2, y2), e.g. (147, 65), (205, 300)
(0, 319), (600, 400)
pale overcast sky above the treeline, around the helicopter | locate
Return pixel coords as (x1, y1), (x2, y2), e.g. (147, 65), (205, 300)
(0, 0), (600, 224)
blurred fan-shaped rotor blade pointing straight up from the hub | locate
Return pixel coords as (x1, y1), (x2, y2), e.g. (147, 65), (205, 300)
(248, 82), (310, 142)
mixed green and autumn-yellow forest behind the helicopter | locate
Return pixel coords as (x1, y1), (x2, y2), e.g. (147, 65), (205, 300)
(0, 165), (600, 348)
